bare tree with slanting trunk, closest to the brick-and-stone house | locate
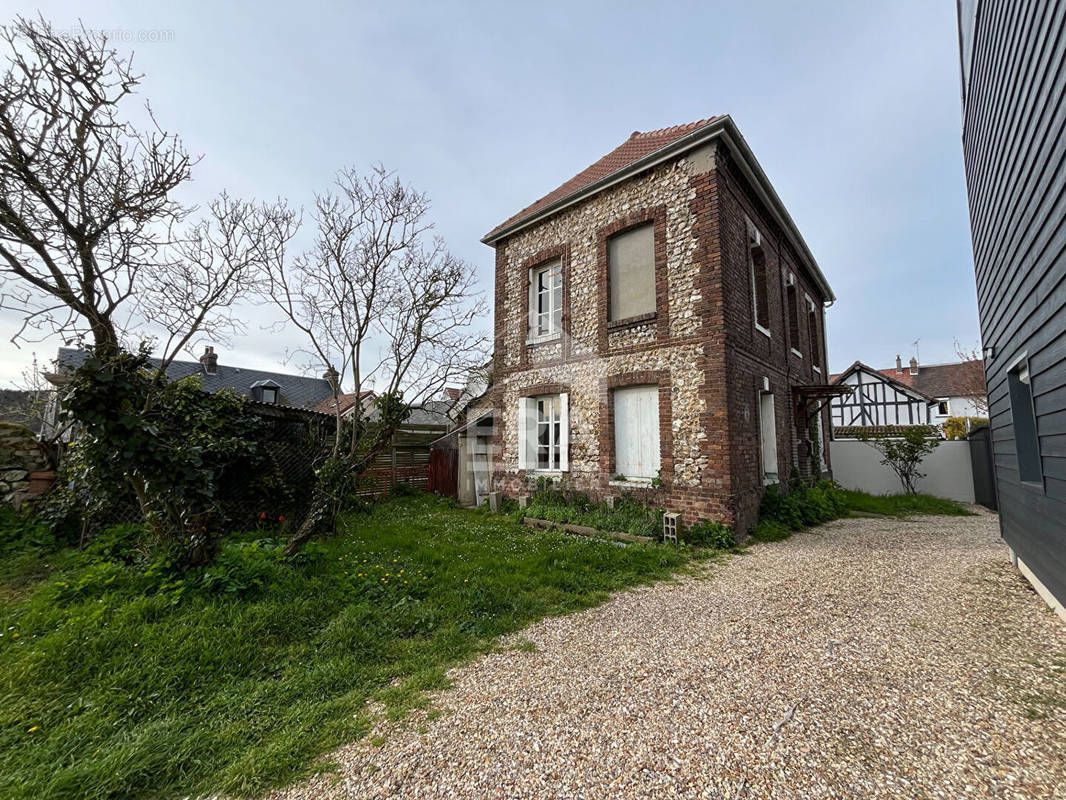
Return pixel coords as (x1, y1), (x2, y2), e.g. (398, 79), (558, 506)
(270, 166), (487, 551)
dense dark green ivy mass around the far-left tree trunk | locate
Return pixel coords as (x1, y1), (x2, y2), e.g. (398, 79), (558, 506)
(63, 346), (261, 565)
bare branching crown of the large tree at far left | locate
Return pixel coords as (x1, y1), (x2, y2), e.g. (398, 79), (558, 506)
(0, 17), (295, 373)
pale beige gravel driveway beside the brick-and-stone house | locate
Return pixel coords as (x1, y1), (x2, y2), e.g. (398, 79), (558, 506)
(272, 514), (1066, 800)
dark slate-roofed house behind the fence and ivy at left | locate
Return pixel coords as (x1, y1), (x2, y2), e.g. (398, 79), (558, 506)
(45, 347), (333, 430)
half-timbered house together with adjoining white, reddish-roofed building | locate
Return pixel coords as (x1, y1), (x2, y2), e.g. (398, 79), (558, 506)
(829, 355), (987, 428)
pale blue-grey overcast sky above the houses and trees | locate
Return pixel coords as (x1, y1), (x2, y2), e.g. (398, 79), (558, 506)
(0, 0), (979, 385)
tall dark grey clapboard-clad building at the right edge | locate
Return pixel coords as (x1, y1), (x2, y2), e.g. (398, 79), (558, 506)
(958, 0), (1066, 620)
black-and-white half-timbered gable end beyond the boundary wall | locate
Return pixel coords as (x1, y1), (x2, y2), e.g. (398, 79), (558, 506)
(829, 362), (934, 430)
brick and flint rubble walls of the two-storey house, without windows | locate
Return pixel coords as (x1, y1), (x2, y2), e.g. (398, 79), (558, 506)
(486, 144), (829, 533)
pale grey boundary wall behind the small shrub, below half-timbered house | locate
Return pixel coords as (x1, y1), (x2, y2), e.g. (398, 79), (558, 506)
(829, 439), (973, 502)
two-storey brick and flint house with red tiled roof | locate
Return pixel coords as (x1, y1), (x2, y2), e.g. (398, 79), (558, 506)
(469, 116), (835, 531)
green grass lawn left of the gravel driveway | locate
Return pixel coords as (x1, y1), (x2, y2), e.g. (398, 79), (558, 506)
(0, 497), (690, 800)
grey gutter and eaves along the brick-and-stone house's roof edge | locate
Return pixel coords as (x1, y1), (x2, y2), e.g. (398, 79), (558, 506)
(481, 114), (837, 304)
